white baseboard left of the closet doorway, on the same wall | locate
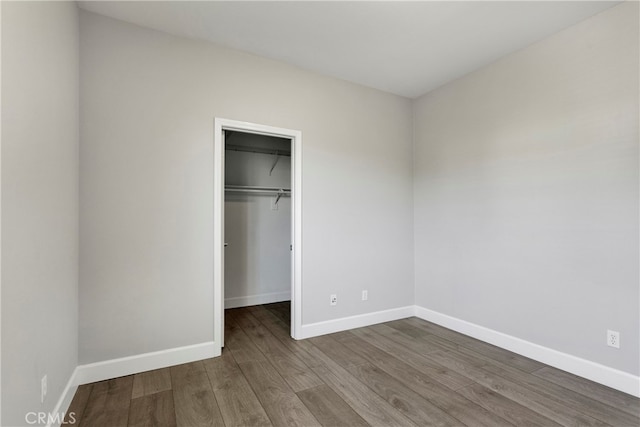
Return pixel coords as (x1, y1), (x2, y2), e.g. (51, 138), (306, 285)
(75, 341), (220, 385)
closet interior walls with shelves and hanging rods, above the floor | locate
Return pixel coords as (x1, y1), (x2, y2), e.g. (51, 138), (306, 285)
(224, 131), (292, 314)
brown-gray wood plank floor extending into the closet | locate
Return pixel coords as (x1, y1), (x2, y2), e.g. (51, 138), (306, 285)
(67, 303), (640, 427)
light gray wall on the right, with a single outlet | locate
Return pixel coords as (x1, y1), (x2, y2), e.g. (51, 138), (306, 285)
(414, 2), (640, 375)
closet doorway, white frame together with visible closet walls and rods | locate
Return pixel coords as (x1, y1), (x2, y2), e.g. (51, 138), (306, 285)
(213, 119), (302, 355)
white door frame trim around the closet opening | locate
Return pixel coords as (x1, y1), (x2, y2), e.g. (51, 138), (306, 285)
(213, 117), (302, 355)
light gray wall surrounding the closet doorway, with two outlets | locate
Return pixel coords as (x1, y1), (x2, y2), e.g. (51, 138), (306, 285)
(80, 12), (414, 363)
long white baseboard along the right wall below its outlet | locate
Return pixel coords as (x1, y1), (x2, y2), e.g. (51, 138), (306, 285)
(415, 306), (640, 397)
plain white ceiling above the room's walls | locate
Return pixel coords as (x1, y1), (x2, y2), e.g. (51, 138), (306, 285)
(79, 1), (618, 98)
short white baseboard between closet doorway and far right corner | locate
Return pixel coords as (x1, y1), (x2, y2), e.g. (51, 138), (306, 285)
(298, 305), (414, 339)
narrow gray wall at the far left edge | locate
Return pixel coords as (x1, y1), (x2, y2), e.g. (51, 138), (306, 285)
(1, 2), (79, 426)
